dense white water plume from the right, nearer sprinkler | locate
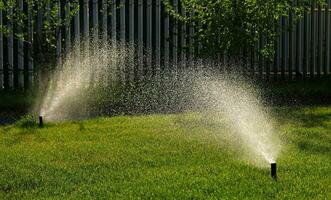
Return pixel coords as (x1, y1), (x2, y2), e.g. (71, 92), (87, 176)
(195, 75), (281, 166)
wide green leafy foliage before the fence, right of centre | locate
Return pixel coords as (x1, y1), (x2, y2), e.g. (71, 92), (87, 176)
(163, 0), (323, 58)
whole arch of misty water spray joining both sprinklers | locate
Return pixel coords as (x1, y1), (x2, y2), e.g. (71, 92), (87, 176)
(40, 40), (281, 166)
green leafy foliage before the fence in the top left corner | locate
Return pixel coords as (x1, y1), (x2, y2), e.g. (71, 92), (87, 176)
(0, 0), (79, 47)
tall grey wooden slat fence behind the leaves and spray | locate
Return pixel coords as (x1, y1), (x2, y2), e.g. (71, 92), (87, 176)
(0, 0), (331, 90)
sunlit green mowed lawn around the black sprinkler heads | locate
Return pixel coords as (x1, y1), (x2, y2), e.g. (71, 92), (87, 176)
(0, 107), (331, 199)
